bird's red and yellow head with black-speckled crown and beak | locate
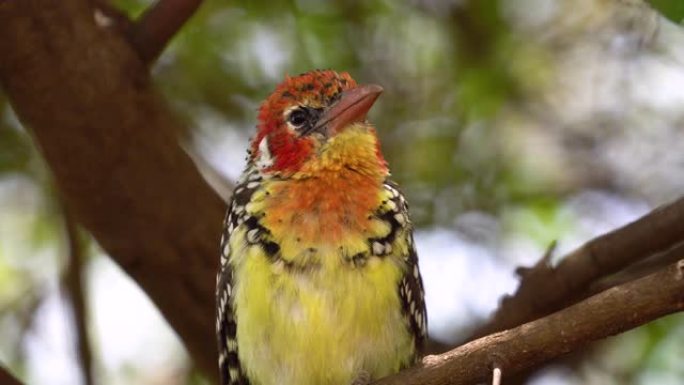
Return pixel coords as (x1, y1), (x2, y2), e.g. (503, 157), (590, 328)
(250, 70), (387, 177)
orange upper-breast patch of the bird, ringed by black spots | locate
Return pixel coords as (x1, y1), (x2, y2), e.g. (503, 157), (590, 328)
(247, 172), (390, 268)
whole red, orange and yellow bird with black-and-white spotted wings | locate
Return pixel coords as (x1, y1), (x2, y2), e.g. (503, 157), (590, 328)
(216, 70), (427, 385)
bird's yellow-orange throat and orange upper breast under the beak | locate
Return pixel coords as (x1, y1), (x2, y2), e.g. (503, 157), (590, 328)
(264, 123), (389, 245)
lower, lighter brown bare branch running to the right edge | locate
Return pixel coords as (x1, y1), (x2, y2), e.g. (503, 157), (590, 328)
(374, 255), (684, 385)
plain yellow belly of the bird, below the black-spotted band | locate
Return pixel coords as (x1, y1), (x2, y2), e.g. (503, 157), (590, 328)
(233, 237), (412, 385)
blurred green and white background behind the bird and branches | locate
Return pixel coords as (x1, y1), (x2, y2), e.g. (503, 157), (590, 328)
(0, 0), (684, 385)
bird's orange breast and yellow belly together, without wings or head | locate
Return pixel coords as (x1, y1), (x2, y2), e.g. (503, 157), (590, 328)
(231, 176), (413, 385)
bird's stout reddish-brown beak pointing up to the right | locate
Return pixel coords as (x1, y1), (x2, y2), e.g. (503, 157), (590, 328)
(313, 84), (382, 138)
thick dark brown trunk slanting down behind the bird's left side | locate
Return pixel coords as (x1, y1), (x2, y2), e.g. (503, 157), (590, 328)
(0, 0), (225, 375)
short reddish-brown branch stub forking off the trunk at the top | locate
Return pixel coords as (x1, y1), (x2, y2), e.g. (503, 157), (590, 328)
(131, 0), (202, 64)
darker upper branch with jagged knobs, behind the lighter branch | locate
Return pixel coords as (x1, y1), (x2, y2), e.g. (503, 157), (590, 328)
(473, 198), (684, 338)
